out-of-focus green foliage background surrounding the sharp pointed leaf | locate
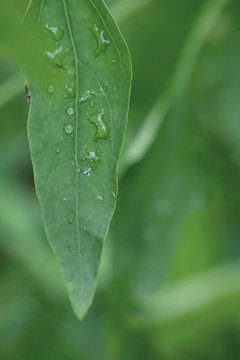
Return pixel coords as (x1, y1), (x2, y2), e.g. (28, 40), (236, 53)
(0, 0), (240, 360)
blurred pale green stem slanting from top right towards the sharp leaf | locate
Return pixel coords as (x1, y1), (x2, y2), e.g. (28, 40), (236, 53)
(119, 0), (229, 176)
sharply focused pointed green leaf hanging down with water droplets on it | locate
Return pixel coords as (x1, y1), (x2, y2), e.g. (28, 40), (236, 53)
(22, 0), (131, 319)
